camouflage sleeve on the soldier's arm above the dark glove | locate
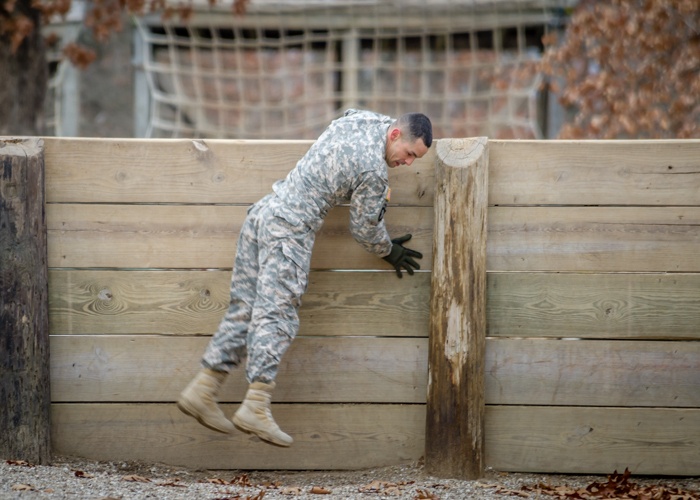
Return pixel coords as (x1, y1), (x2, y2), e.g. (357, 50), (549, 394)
(350, 172), (391, 257)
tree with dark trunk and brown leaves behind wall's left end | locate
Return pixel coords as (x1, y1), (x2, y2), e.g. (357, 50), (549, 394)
(0, 0), (248, 136)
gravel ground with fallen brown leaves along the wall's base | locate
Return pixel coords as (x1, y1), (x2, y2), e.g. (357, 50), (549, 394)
(0, 457), (700, 500)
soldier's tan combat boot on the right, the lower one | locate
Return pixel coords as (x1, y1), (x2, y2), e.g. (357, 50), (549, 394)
(232, 382), (294, 446)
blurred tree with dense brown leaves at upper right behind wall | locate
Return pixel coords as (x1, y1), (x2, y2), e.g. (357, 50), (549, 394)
(543, 0), (700, 139)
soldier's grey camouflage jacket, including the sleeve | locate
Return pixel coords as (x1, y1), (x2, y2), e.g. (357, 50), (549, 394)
(272, 109), (394, 257)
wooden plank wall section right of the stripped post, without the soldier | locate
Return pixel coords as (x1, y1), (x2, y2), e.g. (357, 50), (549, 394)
(485, 141), (700, 475)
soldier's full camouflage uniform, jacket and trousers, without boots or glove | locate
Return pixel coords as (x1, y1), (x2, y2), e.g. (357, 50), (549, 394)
(202, 110), (394, 383)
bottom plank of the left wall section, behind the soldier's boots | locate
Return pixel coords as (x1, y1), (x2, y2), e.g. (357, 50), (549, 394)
(51, 402), (425, 470)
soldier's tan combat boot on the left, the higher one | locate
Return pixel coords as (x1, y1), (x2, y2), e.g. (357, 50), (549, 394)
(177, 368), (234, 434)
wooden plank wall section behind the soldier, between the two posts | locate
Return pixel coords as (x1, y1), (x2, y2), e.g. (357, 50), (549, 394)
(46, 139), (433, 469)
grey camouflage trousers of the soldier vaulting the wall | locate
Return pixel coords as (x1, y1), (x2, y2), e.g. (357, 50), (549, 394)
(202, 194), (315, 383)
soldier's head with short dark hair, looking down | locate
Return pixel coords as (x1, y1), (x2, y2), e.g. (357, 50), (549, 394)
(385, 113), (433, 168)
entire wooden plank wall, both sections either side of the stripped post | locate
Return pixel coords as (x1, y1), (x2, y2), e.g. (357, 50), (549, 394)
(46, 139), (700, 475)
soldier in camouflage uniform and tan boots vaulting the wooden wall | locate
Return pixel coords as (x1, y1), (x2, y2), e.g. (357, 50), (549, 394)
(178, 109), (433, 446)
